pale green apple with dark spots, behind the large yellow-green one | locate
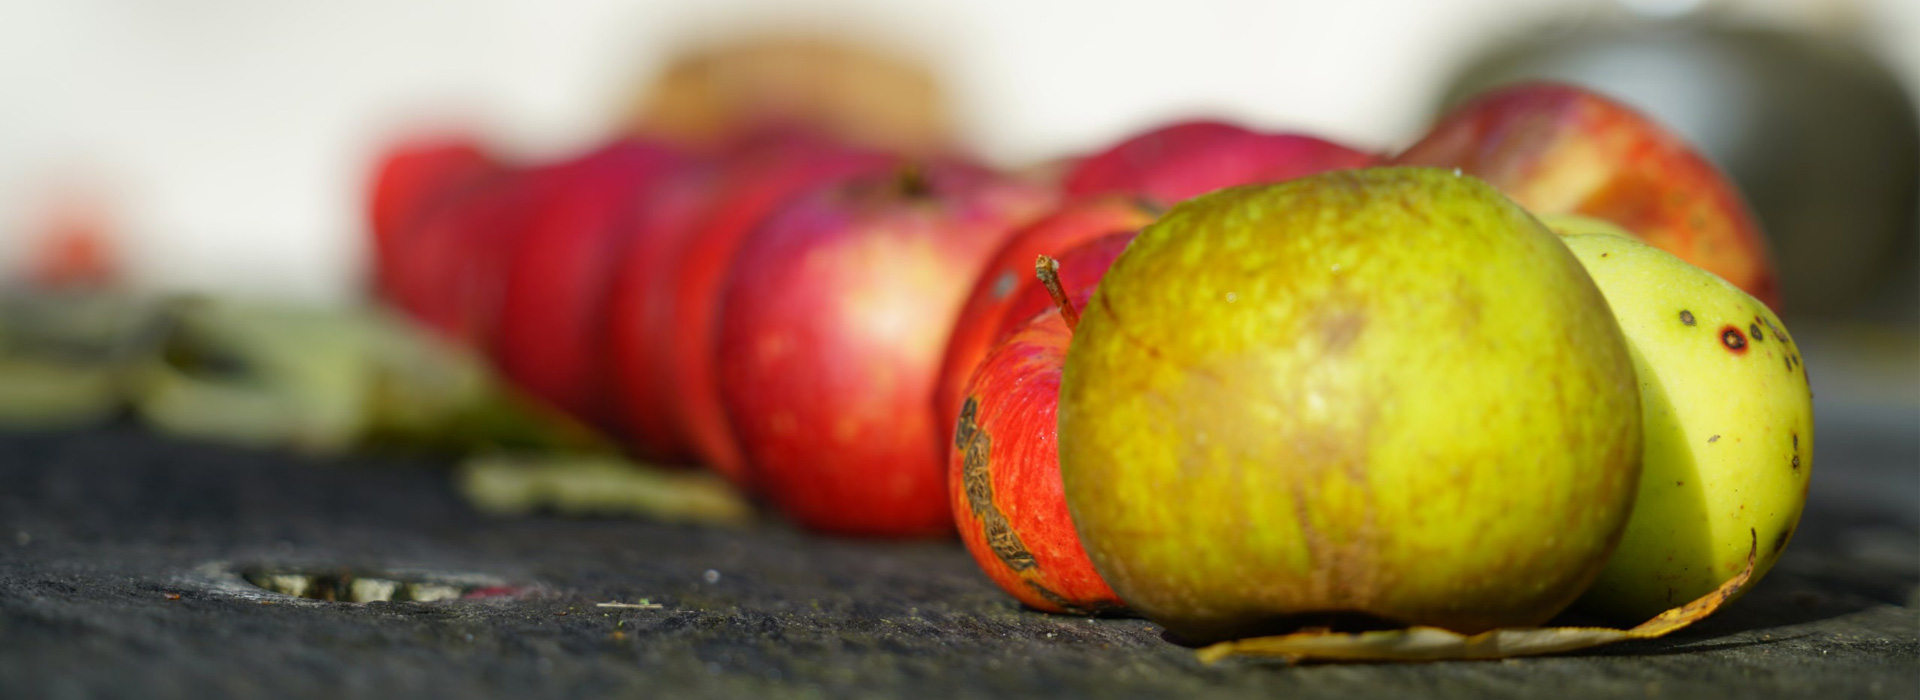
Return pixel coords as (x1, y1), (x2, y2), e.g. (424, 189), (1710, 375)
(1563, 234), (1812, 621)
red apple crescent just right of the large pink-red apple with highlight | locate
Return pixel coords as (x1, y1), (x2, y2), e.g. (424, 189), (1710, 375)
(933, 196), (1160, 445)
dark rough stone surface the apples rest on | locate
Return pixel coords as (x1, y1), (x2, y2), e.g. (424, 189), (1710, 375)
(0, 428), (1920, 698)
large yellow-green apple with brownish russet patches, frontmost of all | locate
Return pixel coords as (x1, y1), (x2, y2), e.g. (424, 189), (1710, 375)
(1058, 169), (1642, 642)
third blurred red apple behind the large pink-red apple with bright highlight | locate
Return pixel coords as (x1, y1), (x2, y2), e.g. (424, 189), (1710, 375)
(493, 140), (689, 426)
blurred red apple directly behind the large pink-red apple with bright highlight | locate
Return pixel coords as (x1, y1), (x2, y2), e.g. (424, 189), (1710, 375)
(660, 136), (900, 485)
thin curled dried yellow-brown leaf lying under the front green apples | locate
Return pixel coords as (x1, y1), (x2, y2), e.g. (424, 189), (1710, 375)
(1198, 531), (1759, 664)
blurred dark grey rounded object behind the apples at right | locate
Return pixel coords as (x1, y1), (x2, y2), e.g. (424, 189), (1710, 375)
(1440, 4), (1920, 322)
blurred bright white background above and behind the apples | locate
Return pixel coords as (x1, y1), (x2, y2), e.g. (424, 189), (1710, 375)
(0, 0), (1920, 301)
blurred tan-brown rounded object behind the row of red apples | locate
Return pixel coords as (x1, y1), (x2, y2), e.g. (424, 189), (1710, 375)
(630, 35), (950, 153)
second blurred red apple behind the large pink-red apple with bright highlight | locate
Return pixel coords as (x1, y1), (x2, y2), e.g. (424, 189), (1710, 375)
(601, 163), (739, 460)
